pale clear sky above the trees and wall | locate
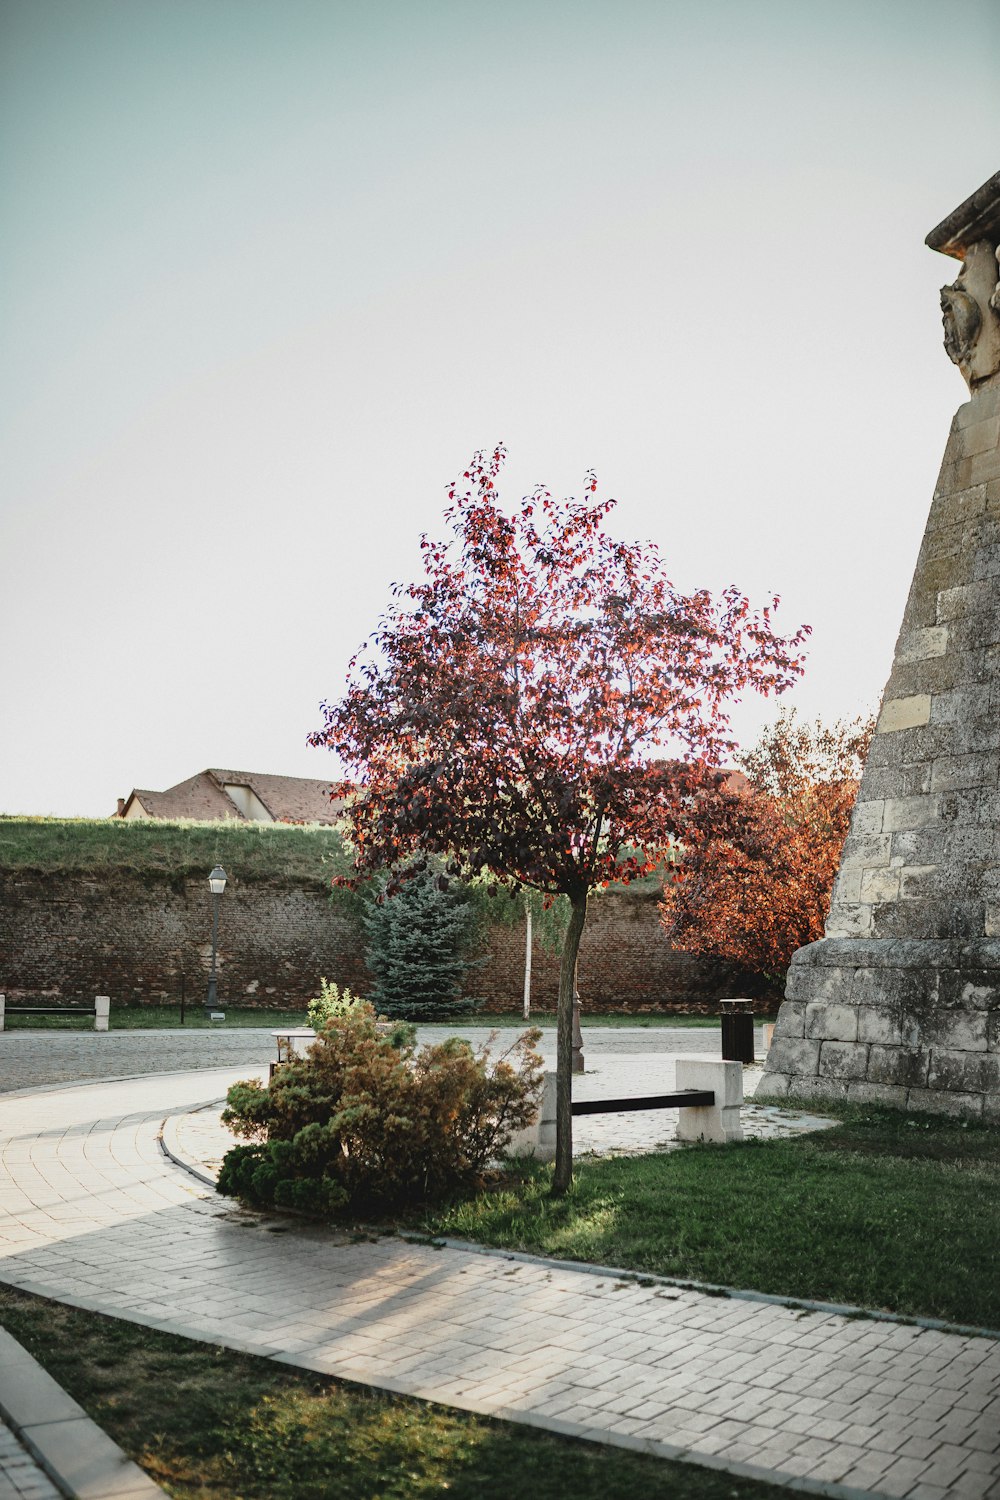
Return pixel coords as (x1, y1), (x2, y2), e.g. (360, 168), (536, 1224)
(0, 0), (1000, 816)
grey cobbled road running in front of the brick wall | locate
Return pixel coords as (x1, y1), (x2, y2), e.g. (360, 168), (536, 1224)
(0, 1011), (749, 1094)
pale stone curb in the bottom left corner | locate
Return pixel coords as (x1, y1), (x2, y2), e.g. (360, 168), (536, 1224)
(0, 1329), (166, 1500)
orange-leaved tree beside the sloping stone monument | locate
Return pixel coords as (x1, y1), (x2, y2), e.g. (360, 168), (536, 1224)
(660, 710), (874, 990)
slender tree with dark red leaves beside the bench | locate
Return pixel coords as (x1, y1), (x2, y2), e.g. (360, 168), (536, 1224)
(310, 447), (805, 1193)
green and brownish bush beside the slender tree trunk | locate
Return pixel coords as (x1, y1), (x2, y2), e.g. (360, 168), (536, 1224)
(219, 1005), (541, 1215)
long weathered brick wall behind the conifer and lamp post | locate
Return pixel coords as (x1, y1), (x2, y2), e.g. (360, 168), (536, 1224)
(0, 872), (741, 1013)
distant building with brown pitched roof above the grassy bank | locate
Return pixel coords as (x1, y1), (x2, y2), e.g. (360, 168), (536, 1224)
(111, 770), (343, 824)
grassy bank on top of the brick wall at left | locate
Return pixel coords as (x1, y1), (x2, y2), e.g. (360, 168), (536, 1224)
(0, 816), (349, 888)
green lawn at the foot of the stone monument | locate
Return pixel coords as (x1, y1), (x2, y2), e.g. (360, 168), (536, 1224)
(426, 1109), (1000, 1329)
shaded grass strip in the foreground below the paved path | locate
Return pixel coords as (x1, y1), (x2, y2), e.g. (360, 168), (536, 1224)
(0, 1287), (786, 1500)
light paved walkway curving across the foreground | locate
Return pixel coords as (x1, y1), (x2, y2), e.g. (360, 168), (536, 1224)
(0, 1070), (1000, 1500)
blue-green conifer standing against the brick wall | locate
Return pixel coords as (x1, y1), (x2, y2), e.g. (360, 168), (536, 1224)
(364, 870), (478, 1022)
